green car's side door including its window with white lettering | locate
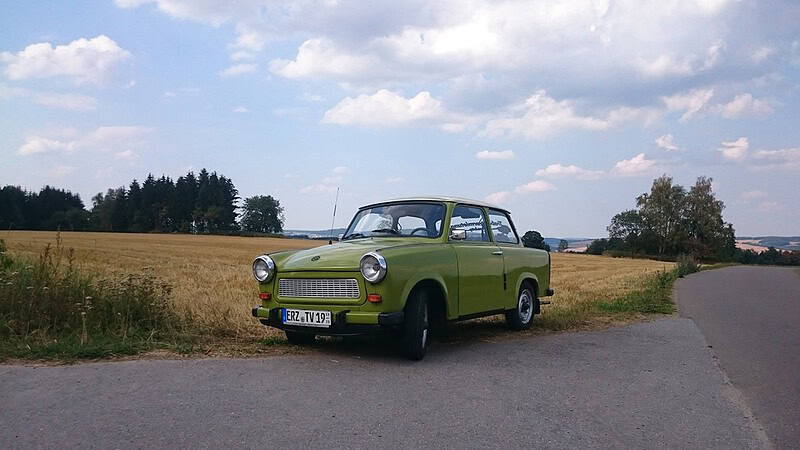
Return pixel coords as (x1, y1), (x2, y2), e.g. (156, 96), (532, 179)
(450, 205), (503, 317)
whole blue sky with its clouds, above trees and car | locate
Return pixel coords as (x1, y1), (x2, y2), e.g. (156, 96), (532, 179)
(0, 0), (800, 236)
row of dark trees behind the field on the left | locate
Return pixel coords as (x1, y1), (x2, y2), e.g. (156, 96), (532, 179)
(0, 169), (284, 233)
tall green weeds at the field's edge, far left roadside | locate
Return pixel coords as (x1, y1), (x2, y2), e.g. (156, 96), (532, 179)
(0, 236), (180, 354)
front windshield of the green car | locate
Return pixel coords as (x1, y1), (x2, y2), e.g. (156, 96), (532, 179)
(342, 203), (445, 240)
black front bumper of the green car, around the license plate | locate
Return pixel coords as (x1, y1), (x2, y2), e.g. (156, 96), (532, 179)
(252, 306), (405, 336)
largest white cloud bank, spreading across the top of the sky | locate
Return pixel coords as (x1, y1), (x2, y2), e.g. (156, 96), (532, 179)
(116, 0), (741, 95)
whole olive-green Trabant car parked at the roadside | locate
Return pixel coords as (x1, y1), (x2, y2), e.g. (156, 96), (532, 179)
(253, 197), (553, 359)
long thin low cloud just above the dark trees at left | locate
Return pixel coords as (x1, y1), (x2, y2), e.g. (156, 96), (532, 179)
(18, 126), (152, 156)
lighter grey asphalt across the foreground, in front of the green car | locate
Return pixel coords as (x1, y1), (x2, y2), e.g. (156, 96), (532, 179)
(0, 318), (770, 449)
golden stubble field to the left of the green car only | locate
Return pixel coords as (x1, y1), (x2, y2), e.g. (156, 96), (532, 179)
(0, 231), (322, 338)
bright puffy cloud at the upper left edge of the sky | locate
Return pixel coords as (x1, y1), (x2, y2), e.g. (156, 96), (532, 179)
(0, 35), (131, 84)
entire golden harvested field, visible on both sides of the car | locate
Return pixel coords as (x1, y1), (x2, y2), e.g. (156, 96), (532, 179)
(0, 231), (673, 339)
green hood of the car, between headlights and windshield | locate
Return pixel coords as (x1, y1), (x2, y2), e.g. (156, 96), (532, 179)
(270, 238), (427, 272)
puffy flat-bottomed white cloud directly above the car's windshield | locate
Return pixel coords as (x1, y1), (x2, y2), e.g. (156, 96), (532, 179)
(322, 89), (470, 132)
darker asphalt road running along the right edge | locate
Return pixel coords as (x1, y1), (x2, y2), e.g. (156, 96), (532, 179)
(676, 266), (800, 448)
